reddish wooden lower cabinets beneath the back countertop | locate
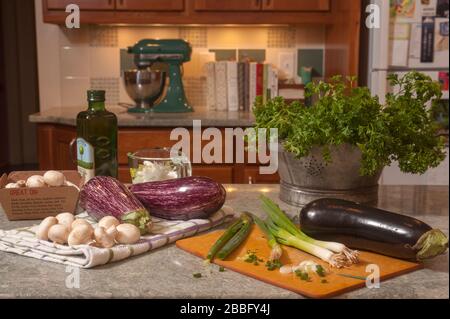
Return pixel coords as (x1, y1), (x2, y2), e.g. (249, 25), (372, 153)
(38, 124), (278, 183)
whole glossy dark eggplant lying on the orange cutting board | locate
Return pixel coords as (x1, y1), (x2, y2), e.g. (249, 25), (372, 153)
(300, 198), (448, 260)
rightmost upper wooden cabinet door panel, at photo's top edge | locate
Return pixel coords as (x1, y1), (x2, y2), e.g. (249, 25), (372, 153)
(261, 0), (330, 11)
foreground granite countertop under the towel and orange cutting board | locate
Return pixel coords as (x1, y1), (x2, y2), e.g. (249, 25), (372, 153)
(0, 185), (449, 299)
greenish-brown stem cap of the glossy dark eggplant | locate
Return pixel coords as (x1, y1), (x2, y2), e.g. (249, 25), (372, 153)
(411, 229), (448, 260)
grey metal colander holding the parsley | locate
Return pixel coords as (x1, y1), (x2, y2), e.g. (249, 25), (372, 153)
(278, 144), (382, 207)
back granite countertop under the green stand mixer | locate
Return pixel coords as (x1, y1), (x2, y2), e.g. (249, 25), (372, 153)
(29, 106), (254, 127)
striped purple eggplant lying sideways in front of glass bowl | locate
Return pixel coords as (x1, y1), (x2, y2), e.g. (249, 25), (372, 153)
(130, 176), (226, 220)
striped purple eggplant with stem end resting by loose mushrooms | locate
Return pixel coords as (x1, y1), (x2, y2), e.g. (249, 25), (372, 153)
(79, 176), (152, 235)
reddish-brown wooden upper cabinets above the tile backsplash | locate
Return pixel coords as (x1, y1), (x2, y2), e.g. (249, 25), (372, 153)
(42, 0), (362, 78)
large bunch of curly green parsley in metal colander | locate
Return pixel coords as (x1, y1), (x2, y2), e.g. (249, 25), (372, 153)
(253, 71), (445, 175)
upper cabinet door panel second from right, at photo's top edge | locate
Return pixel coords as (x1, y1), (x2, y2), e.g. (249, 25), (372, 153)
(194, 0), (261, 11)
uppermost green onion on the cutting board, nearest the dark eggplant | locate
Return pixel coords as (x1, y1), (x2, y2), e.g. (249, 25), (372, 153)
(261, 195), (359, 263)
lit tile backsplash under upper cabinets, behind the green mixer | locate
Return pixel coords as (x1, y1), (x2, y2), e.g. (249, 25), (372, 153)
(55, 25), (324, 108)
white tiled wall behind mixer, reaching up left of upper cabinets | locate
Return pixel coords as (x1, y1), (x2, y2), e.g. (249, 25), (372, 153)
(35, 0), (325, 110)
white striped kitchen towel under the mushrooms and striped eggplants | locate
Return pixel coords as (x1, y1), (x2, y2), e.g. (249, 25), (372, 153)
(0, 206), (234, 268)
